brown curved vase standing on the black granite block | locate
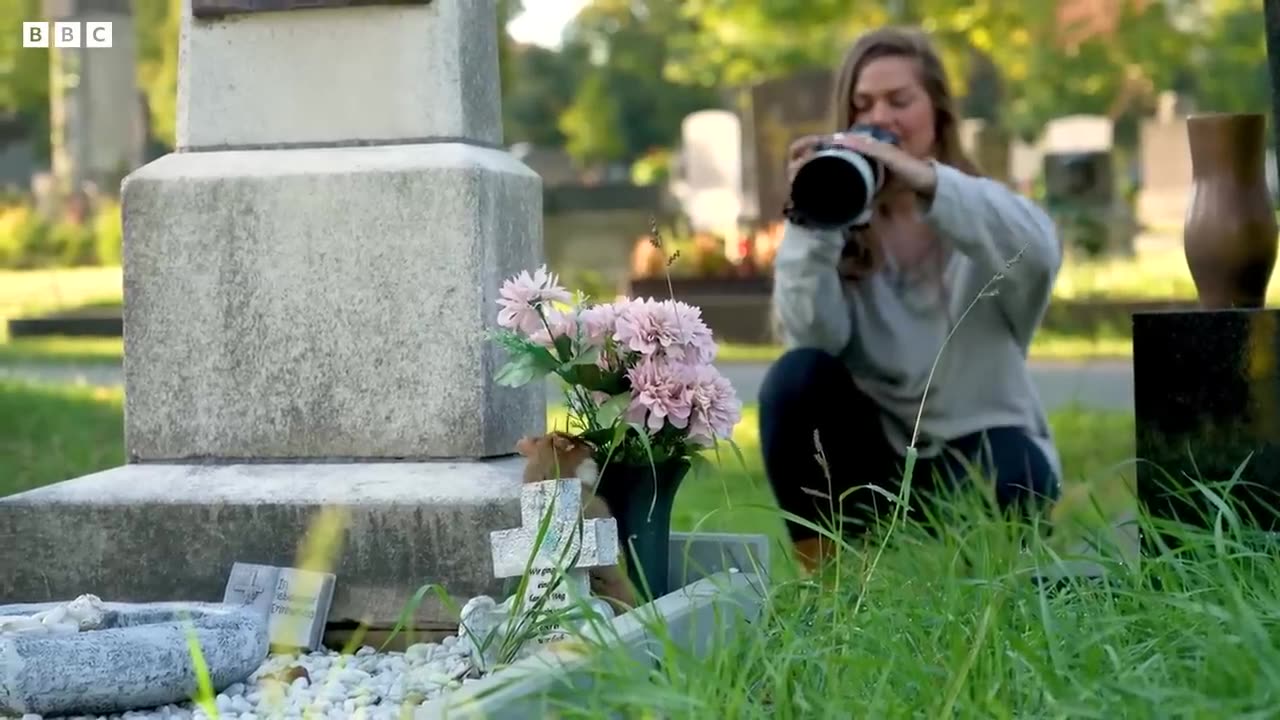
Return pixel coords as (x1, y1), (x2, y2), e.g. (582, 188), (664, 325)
(1183, 113), (1277, 310)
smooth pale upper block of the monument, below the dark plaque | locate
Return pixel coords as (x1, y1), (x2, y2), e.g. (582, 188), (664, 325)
(177, 0), (502, 150)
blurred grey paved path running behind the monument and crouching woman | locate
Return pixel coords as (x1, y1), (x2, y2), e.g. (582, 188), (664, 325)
(0, 360), (1133, 410)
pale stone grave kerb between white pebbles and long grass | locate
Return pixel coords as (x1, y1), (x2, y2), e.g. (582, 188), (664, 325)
(413, 571), (764, 720)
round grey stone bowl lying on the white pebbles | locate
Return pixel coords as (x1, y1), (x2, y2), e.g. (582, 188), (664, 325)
(0, 602), (269, 716)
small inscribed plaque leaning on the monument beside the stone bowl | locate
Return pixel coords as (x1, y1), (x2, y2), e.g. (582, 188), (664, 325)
(223, 562), (337, 650)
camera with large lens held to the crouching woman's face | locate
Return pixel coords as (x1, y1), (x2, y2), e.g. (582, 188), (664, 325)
(790, 124), (899, 229)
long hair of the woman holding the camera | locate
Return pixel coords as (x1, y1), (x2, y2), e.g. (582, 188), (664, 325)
(831, 27), (983, 279)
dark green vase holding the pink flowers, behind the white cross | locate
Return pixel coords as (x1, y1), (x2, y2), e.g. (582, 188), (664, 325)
(596, 457), (690, 603)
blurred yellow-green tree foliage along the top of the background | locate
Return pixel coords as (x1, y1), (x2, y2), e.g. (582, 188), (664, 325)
(0, 0), (1270, 169)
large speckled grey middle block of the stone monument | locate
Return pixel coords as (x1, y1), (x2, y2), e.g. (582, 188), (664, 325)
(123, 142), (547, 461)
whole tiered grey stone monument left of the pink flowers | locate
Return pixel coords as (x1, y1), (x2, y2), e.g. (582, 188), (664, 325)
(0, 0), (547, 630)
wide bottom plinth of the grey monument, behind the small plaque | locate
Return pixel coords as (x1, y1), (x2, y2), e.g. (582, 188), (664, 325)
(0, 457), (524, 629)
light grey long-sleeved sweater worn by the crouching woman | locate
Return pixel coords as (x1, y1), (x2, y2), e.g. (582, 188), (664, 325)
(773, 163), (1062, 479)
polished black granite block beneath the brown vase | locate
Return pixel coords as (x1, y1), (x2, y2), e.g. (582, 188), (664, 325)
(1133, 309), (1280, 551)
